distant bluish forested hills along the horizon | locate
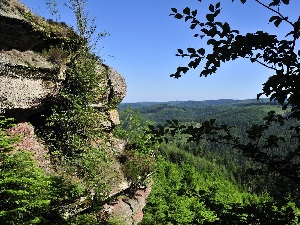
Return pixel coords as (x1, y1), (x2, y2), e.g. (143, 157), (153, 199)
(119, 98), (281, 125)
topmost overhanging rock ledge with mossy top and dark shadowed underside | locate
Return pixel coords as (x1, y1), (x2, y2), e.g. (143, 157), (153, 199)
(0, 0), (79, 51)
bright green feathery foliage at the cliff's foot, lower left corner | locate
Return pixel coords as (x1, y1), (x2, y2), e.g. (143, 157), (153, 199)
(0, 118), (89, 224)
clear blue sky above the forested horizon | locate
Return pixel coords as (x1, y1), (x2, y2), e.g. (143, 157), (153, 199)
(21, 0), (300, 102)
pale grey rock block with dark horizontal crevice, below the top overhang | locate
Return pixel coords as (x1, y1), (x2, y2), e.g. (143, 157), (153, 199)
(0, 49), (63, 120)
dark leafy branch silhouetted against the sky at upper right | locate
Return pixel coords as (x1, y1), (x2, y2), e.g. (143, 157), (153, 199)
(170, 0), (300, 118)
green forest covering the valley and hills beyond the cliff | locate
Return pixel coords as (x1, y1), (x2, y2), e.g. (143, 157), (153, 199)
(119, 99), (300, 224)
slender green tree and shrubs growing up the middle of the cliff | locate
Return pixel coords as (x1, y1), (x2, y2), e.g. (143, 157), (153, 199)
(42, 0), (115, 221)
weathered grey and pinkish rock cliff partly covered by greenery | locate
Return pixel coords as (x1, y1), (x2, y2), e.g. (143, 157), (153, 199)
(0, 0), (150, 224)
